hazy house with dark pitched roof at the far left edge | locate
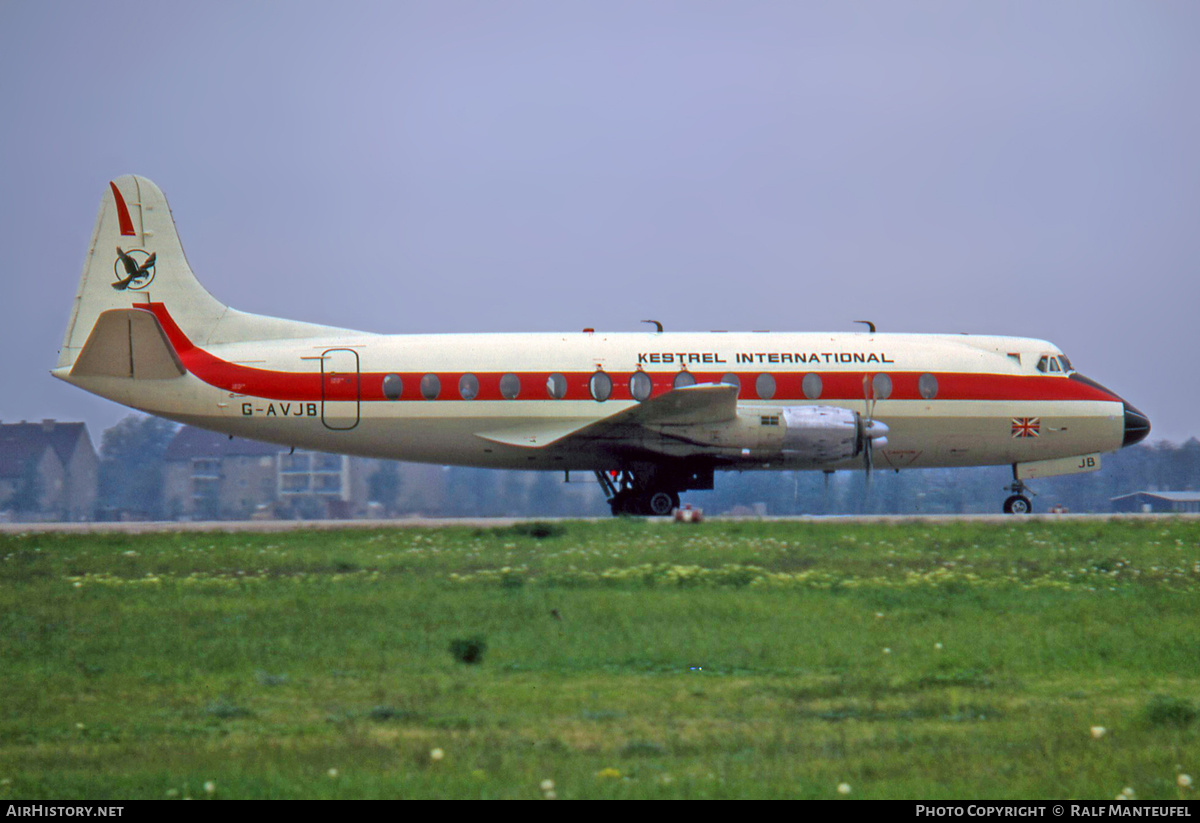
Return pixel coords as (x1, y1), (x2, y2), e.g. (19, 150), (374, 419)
(0, 420), (100, 521)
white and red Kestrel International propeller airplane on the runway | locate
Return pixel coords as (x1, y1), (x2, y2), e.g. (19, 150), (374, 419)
(52, 175), (1150, 516)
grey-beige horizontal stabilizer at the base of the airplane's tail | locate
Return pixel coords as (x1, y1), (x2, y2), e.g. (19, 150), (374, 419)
(71, 308), (186, 380)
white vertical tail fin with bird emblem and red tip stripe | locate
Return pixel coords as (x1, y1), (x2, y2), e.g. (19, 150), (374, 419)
(54, 175), (352, 373)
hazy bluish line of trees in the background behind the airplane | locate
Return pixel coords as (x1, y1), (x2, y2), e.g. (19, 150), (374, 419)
(79, 415), (1200, 518)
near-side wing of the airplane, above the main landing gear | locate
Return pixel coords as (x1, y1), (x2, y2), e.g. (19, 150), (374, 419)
(476, 383), (738, 449)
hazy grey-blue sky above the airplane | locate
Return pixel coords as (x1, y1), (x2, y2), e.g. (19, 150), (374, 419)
(0, 0), (1200, 445)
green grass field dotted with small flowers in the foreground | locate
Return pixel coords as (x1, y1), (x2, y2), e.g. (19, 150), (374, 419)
(0, 519), (1200, 799)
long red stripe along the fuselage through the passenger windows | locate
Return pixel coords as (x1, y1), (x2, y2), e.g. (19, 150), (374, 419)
(133, 302), (1121, 406)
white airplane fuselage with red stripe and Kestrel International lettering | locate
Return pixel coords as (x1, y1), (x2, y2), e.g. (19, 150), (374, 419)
(60, 306), (1124, 469)
